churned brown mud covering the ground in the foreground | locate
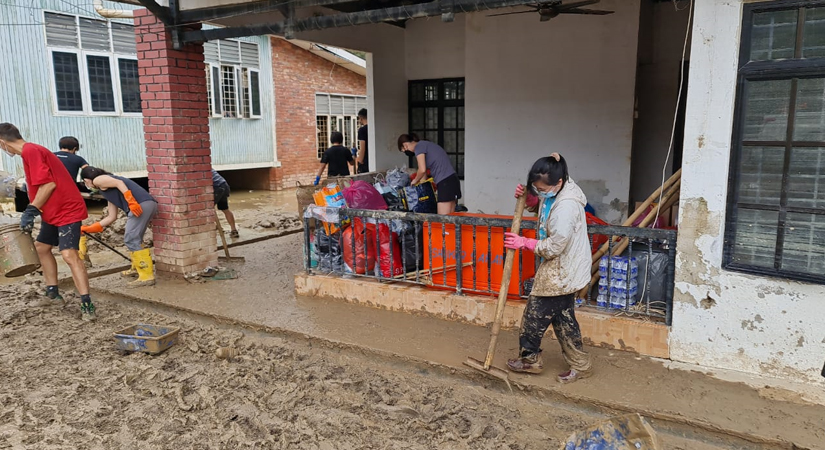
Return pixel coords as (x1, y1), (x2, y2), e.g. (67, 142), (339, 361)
(0, 282), (715, 450)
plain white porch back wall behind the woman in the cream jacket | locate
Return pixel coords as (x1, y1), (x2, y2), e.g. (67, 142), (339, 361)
(465, 0), (639, 222)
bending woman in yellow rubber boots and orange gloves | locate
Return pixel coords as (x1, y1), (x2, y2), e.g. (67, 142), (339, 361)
(80, 166), (158, 287)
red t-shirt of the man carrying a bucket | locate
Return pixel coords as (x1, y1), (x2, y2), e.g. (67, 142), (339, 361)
(21, 142), (89, 227)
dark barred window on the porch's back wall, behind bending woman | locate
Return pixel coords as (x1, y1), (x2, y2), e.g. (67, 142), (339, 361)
(409, 78), (464, 179)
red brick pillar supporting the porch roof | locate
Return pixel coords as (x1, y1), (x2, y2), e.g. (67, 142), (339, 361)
(135, 9), (218, 274)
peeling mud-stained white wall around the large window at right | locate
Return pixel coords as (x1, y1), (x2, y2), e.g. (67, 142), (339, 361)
(670, 1), (825, 383)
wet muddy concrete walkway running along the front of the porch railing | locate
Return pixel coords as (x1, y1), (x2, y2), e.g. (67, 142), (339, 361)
(92, 234), (825, 449)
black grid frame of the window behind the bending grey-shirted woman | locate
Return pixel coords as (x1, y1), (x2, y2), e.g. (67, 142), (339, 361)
(407, 77), (467, 180)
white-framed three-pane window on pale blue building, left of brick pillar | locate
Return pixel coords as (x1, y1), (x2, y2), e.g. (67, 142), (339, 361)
(43, 12), (141, 115)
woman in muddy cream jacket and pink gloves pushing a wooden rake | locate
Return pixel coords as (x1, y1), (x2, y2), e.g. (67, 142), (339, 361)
(504, 153), (591, 383)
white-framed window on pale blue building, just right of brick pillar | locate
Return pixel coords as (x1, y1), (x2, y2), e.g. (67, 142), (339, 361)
(203, 39), (261, 119)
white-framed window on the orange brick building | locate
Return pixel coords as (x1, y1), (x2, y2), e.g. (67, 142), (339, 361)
(315, 94), (367, 159)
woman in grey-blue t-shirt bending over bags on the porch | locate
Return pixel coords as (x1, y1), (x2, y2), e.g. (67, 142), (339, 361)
(398, 133), (461, 214)
